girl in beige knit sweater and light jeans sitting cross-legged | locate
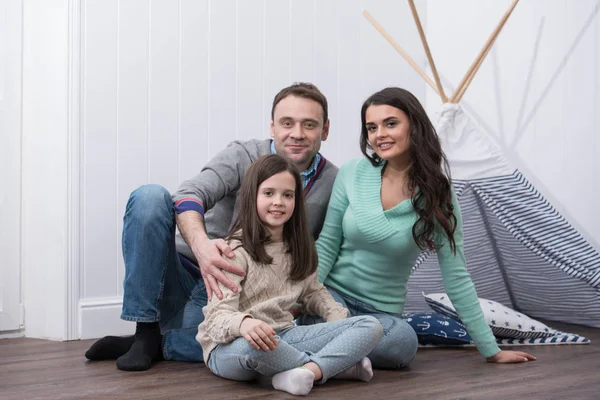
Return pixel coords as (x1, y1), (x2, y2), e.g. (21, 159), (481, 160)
(196, 154), (382, 395)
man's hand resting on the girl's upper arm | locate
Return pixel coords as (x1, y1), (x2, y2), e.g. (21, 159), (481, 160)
(191, 237), (246, 301)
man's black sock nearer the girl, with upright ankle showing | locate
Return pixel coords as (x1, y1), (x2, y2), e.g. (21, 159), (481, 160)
(117, 322), (162, 371)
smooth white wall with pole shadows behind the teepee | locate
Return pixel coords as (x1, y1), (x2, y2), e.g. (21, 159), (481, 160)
(427, 0), (600, 249)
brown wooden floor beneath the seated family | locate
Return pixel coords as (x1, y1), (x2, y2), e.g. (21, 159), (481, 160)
(0, 323), (600, 400)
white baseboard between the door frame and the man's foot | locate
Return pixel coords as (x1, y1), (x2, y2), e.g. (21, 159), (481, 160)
(79, 297), (135, 339)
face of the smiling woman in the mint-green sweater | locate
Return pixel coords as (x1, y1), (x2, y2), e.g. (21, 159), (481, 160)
(365, 104), (410, 166)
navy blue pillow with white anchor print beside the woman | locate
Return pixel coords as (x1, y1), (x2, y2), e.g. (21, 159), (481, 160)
(406, 313), (473, 346)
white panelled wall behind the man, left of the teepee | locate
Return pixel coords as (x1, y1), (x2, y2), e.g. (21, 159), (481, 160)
(80, 0), (425, 337)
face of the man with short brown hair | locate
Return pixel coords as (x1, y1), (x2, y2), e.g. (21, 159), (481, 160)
(271, 95), (329, 171)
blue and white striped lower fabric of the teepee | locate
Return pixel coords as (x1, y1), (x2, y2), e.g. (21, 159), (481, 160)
(405, 170), (600, 328)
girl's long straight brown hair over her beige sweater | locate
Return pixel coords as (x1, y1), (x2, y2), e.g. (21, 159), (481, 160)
(227, 154), (317, 281)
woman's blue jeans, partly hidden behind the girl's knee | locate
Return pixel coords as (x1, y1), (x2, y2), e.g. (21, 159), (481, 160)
(297, 287), (419, 369)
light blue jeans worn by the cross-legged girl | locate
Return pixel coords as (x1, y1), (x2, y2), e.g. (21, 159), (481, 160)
(208, 316), (382, 383)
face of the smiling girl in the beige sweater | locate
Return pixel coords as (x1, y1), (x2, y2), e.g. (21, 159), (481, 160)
(256, 171), (296, 240)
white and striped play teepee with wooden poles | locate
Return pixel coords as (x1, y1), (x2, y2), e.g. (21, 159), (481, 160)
(364, 0), (600, 327)
